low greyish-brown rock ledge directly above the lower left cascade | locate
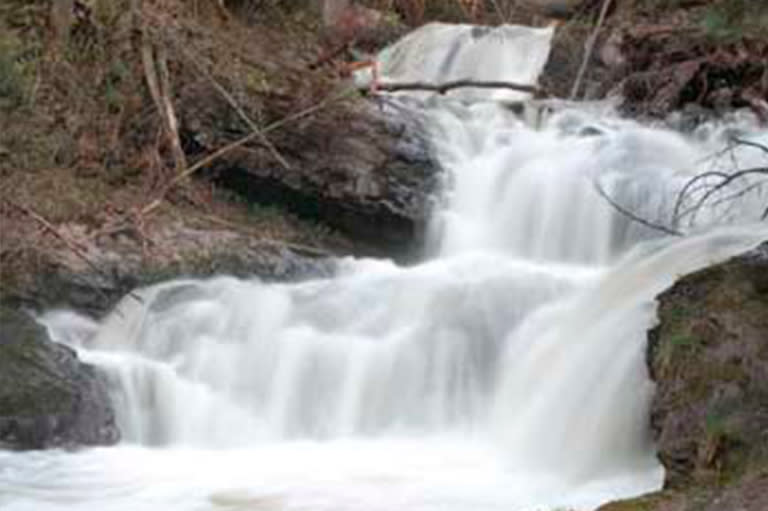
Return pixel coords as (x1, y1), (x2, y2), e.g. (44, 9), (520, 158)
(0, 224), (335, 317)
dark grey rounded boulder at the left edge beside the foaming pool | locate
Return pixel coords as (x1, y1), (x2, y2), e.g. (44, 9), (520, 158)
(0, 307), (119, 449)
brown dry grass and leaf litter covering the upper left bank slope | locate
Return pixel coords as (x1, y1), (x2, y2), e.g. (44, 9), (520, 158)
(0, 0), (348, 300)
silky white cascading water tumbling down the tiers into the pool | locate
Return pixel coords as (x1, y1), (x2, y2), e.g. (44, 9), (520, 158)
(0, 23), (768, 511)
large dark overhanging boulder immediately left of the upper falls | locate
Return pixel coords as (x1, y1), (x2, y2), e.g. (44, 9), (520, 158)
(181, 96), (438, 259)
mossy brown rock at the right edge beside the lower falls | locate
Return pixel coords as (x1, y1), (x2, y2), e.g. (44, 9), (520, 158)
(601, 242), (768, 511)
